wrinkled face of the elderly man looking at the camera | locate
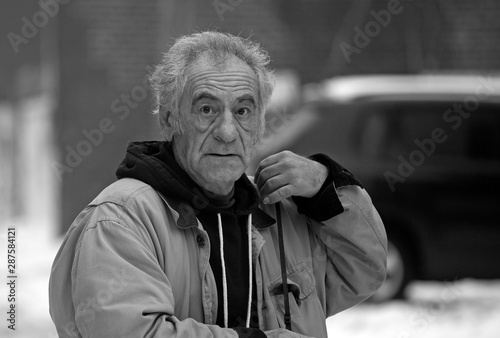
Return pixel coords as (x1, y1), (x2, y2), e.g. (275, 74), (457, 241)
(174, 57), (261, 195)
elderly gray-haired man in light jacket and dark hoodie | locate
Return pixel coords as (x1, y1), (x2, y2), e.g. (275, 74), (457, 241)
(50, 32), (387, 337)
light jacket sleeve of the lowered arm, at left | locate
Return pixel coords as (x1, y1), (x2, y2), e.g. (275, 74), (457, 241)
(65, 206), (263, 337)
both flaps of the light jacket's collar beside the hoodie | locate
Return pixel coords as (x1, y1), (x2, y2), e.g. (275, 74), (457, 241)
(158, 192), (276, 230)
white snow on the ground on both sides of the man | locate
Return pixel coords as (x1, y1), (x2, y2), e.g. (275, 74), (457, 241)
(0, 227), (500, 338)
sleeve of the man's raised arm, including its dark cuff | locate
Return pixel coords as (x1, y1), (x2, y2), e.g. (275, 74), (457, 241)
(293, 155), (387, 316)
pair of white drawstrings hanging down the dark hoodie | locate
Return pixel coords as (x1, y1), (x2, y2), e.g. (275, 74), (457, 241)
(217, 213), (253, 328)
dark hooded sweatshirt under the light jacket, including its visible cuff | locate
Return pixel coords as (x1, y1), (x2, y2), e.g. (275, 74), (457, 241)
(116, 141), (361, 337)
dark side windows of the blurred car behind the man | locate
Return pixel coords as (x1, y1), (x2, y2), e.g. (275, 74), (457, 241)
(354, 102), (500, 164)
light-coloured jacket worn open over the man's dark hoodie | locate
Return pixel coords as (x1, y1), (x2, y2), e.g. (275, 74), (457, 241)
(49, 178), (387, 338)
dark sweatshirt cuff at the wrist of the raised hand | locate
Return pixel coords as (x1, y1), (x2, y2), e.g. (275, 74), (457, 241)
(292, 154), (362, 222)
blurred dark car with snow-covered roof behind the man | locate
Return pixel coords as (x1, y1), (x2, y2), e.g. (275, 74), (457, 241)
(250, 75), (500, 301)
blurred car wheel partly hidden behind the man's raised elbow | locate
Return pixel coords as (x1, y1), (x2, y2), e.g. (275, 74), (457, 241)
(370, 238), (412, 302)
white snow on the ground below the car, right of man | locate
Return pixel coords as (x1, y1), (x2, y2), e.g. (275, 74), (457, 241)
(327, 280), (500, 338)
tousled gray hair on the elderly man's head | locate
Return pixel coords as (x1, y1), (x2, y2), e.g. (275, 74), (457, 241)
(149, 31), (274, 132)
